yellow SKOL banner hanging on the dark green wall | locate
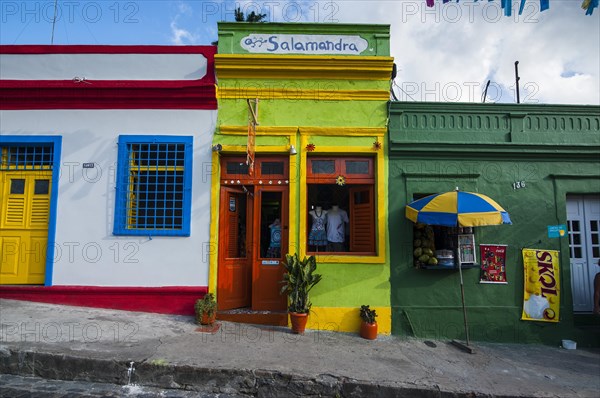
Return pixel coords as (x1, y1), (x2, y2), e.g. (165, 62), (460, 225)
(521, 249), (560, 322)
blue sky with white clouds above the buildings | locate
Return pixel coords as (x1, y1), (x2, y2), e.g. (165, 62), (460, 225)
(0, 0), (600, 104)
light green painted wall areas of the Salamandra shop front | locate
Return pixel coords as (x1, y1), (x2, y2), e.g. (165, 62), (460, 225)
(214, 23), (391, 314)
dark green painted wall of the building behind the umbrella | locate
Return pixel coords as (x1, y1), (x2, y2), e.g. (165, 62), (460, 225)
(389, 103), (600, 346)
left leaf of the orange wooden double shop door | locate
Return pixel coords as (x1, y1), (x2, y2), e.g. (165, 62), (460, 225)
(217, 187), (253, 310)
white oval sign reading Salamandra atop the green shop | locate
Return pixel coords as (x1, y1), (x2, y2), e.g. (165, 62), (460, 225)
(240, 33), (369, 55)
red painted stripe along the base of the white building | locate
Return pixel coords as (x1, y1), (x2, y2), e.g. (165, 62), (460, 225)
(0, 286), (208, 315)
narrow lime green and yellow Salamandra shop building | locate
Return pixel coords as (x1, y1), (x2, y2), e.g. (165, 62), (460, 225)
(209, 23), (393, 334)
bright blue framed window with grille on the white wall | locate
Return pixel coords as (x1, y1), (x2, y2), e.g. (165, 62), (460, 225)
(113, 135), (193, 236)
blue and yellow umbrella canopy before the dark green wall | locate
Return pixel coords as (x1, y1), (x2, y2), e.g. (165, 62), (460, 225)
(406, 189), (512, 227)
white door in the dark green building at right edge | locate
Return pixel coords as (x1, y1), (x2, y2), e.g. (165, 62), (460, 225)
(567, 195), (600, 312)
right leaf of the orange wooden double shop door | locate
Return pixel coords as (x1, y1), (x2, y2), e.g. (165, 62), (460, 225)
(252, 186), (288, 311)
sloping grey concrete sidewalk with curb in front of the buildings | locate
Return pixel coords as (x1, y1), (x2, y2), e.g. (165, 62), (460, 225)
(0, 300), (600, 397)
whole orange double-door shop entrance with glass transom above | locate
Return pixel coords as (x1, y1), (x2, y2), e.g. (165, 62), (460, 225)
(217, 158), (289, 319)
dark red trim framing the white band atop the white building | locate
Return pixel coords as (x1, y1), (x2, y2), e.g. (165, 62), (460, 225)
(0, 45), (217, 110)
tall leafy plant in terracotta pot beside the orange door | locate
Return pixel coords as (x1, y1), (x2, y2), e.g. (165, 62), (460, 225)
(281, 254), (321, 334)
